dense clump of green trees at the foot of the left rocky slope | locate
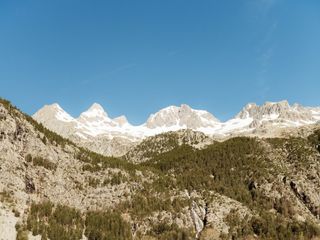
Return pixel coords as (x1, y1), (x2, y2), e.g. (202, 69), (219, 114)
(21, 202), (132, 240)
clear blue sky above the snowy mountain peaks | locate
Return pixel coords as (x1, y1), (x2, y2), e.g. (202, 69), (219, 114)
(0, 0), (320, 124)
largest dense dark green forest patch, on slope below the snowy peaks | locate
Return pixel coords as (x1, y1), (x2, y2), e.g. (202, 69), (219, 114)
(143, 138), (268, 204)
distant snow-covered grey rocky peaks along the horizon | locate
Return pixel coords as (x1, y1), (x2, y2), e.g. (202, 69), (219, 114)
(33, 101), (320, 141)
